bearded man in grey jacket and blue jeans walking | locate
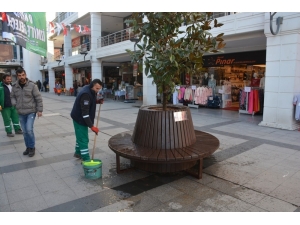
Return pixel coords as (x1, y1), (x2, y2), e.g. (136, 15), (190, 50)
(10, 68), (43, 157)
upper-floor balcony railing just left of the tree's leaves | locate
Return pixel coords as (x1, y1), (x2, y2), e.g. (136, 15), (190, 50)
(97, 28), (134, 48)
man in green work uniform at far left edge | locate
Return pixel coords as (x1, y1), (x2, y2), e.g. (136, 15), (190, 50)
(0, 74), (23, 137)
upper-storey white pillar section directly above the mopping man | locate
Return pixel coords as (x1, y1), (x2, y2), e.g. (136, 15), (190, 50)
(90, 12), (101, 51)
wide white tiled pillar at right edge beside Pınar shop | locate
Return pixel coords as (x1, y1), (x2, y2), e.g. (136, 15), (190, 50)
(259, 13), (300, 130)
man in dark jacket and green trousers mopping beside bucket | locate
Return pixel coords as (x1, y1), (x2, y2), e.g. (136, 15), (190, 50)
(71, 79), (103, 161)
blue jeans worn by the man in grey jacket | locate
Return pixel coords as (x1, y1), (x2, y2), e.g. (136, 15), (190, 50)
(19, 113), (36, 148)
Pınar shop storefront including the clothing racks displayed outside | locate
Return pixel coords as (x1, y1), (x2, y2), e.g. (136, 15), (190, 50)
(177, 50), (266, 111)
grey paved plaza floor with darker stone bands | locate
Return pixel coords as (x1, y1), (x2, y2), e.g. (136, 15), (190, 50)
(0, 92), (300, 216)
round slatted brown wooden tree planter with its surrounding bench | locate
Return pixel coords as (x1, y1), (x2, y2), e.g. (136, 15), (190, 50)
(108, 105), (219, 178)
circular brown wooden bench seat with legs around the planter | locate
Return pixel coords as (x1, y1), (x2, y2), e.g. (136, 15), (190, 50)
(108, 130), (220, 179)
